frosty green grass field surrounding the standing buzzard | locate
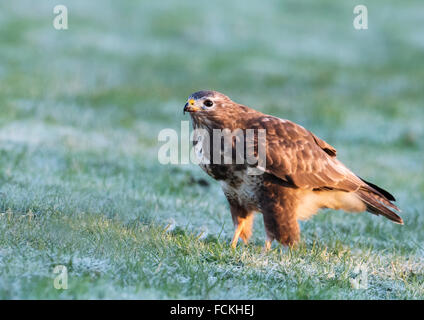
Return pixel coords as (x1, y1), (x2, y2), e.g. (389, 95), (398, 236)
(0, 0), (424, 299)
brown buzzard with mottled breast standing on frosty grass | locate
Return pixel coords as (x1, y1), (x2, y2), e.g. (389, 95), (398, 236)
(184, 90), (403, 250)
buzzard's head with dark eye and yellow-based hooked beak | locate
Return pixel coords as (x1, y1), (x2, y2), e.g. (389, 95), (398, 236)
(184, 90), (232, 116)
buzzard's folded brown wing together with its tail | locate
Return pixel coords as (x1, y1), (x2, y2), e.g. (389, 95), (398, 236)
(245, 115), (403, 223)
